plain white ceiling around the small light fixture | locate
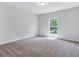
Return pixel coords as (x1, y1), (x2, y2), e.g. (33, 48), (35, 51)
(6, 2), (79, 14)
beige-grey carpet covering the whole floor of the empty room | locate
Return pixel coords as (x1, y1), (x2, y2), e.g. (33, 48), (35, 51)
(0, 37), (79, 57)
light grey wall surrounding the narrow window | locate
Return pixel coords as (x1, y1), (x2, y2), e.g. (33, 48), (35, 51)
(38, 7), (79, 41)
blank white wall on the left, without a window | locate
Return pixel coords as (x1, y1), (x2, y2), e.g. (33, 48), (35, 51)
(0, 3), (37, 44)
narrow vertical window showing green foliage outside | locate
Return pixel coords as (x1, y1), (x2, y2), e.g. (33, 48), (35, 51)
(49, 17), (58, 34)
